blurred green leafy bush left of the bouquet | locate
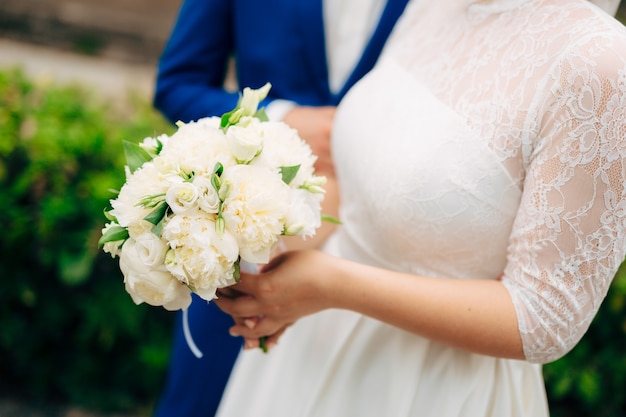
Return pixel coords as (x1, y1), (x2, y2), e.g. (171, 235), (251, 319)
(0, 70), (172, 410)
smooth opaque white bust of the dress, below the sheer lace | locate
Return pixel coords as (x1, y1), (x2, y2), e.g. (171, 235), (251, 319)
(333, 57), (521, 269)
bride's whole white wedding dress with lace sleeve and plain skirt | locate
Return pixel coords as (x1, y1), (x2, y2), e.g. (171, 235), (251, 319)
(213, 0), (626, 417)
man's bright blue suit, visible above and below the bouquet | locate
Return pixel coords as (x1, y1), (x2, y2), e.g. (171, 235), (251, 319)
(154, 0), (408, 417)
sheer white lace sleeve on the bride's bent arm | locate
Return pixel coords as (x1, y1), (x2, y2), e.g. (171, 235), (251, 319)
(503, 36), (626, 363)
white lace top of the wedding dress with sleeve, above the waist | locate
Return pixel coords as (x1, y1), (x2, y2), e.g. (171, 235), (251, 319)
(333, 0), (626, 362)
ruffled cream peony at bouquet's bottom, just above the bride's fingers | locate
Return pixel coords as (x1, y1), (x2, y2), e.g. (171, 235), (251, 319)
(163, 211), (239, 300)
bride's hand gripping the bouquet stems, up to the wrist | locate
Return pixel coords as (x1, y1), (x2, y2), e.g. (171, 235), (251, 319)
(215, 250), (332, 348)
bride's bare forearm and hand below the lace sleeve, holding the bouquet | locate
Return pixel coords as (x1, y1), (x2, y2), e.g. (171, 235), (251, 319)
(217, 251), (524, 359)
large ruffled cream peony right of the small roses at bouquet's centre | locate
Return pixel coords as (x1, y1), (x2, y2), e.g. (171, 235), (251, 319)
(222, 165), (291, 263)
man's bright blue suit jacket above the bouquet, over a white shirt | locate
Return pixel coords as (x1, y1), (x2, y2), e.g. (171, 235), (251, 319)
(154, 0), (407, 122)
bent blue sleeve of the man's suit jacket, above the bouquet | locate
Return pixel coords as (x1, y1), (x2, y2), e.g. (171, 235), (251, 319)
(154, 0), (238, 123)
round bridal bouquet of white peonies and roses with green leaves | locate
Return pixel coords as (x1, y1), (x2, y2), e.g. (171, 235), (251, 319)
(99, 84), (326, 316)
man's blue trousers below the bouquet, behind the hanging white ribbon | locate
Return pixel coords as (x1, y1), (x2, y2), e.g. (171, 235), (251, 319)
(154, 295), (243, 417)
